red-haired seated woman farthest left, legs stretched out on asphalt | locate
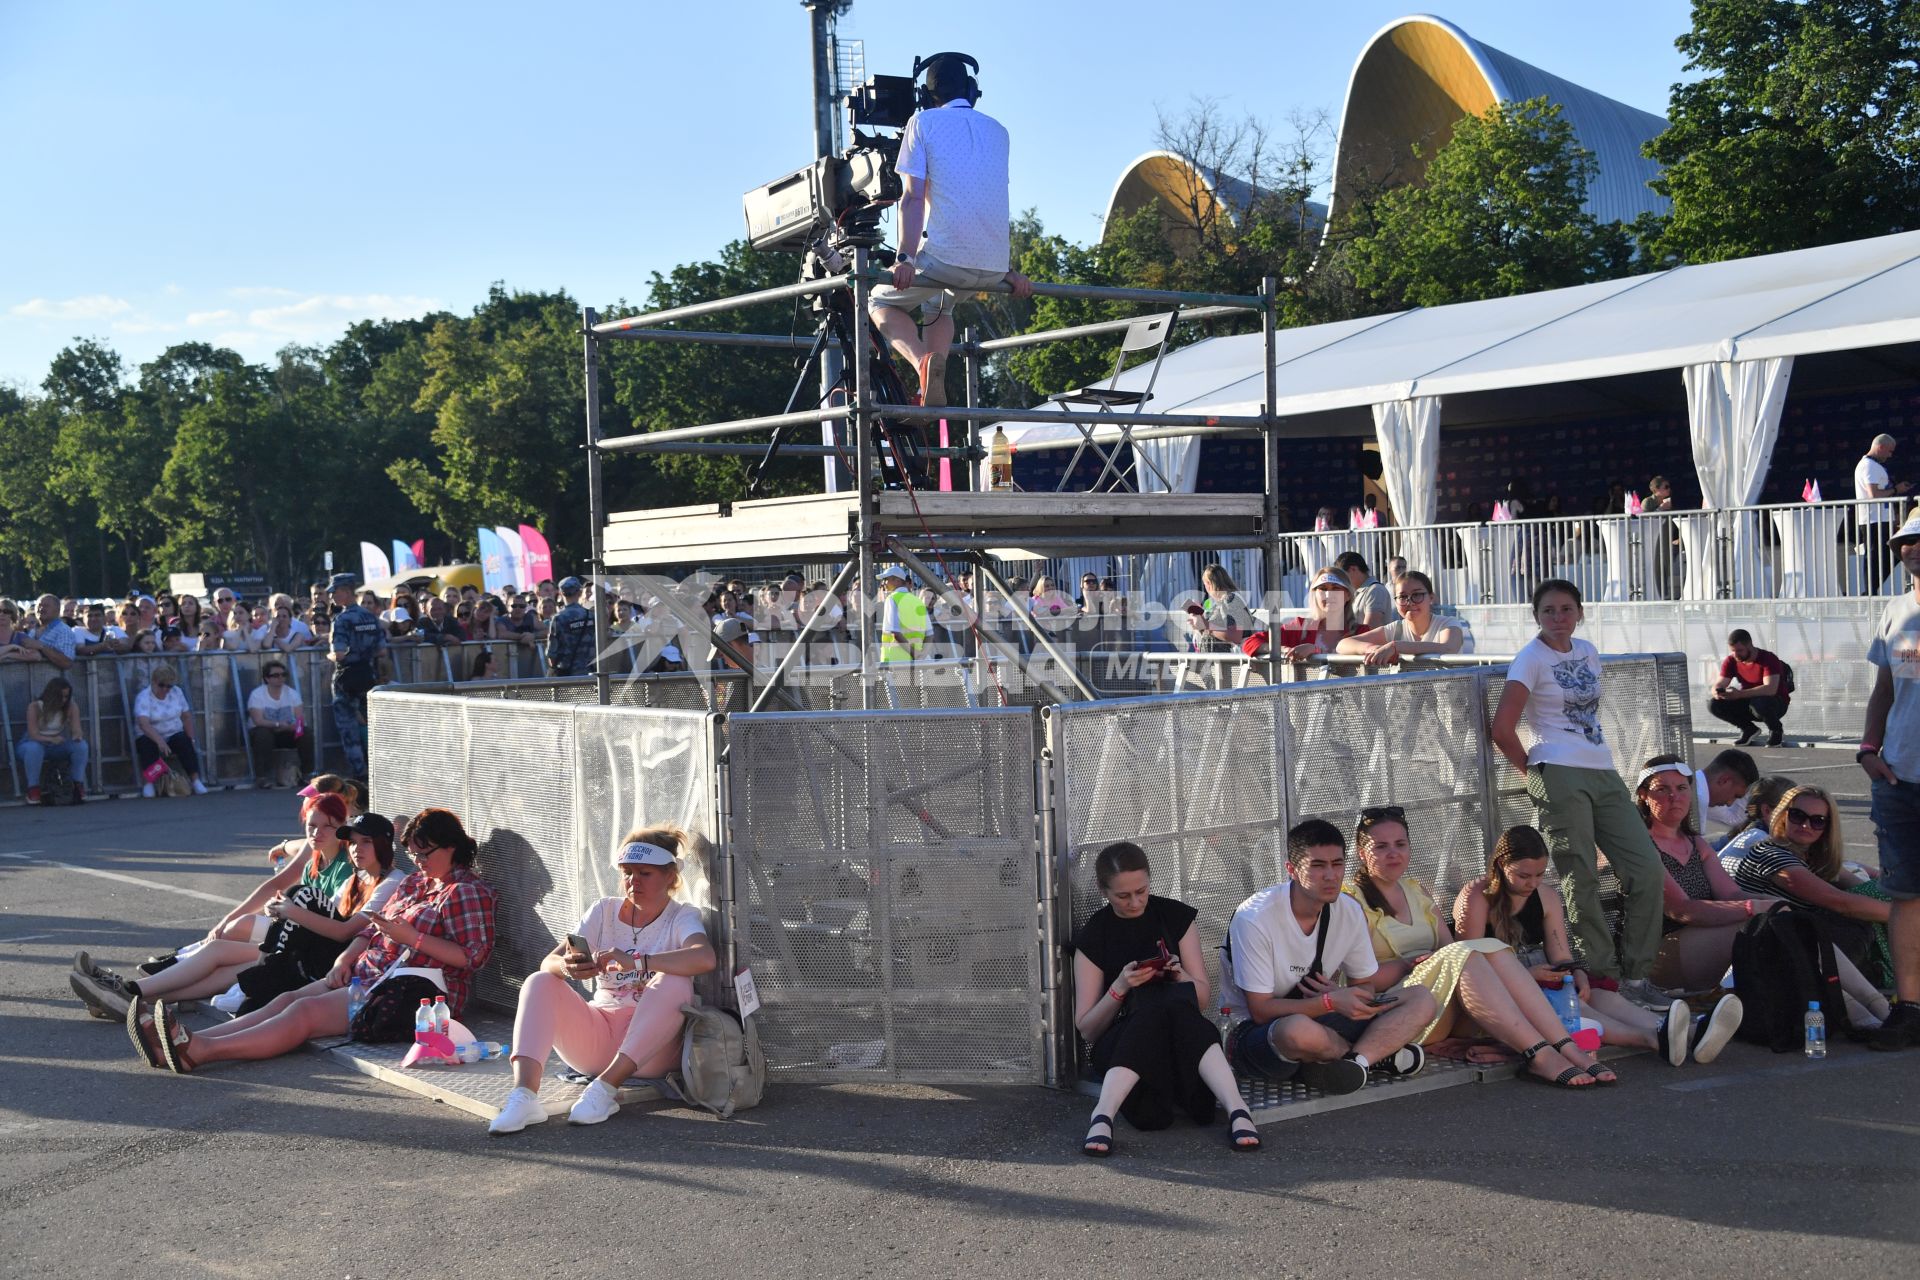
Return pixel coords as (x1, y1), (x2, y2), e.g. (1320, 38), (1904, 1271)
(67, 796), (353, 1019)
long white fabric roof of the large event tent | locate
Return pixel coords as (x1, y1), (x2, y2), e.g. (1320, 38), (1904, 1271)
(1010, 232), (1920, 439)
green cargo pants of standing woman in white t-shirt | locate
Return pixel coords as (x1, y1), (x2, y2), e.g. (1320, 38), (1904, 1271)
(1526, 764), (1667, 981)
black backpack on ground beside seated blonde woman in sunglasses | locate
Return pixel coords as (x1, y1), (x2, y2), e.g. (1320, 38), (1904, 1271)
(1734, 904), (1851, 1054)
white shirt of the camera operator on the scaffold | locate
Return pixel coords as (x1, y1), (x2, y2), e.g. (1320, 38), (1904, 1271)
(897, 100), (1012, 271)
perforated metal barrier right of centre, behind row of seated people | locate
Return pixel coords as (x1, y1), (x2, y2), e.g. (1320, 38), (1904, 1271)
(1043, 654), (1692, 1080)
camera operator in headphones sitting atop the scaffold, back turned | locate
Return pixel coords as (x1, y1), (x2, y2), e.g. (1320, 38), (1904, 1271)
(868, 54), (1033, 405)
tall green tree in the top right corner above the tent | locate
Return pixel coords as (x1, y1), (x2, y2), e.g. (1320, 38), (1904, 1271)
(1645, 0), (1920, 263)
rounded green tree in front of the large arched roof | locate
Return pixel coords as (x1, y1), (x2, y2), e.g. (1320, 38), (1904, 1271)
(1346, 98), (1632, 311)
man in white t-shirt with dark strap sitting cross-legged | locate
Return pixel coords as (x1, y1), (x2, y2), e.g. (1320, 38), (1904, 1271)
(1221, 818), (1436, 1094)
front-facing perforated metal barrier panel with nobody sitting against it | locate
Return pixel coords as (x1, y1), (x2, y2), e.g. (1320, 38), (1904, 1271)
(726, 710), (1044, 1082)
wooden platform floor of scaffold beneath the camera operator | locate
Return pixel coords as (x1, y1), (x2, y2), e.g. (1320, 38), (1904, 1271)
(607, 489), (1265, 568)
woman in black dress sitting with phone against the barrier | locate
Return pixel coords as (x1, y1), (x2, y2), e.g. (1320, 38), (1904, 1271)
(1073, 842), (1260, 1155)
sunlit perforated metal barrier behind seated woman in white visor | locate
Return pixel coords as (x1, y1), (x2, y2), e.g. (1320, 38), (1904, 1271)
(369, 689), (732, 1009)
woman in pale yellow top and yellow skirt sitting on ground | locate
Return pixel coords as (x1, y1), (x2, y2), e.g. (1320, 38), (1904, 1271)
(1348, 804), (1619, 1088)
